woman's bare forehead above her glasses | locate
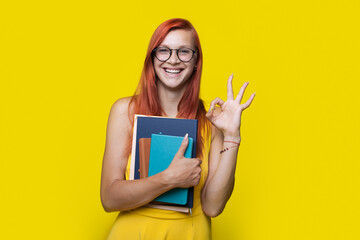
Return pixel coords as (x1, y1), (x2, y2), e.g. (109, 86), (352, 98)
(160, 29), (195, 48)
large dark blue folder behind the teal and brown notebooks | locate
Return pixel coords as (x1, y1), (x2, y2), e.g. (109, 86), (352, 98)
(134, 116), (198, 208)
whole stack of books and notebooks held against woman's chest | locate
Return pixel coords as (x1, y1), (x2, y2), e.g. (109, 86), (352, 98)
(129, 115), (198, 213)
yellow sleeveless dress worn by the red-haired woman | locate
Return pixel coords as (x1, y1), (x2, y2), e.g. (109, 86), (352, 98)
(107, 131), (211, 240)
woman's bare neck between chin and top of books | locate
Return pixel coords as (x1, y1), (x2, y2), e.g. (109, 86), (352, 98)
(158, 82), (186, 117)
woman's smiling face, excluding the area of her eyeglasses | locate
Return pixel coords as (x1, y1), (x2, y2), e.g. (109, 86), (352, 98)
(154, 29), (197, 91)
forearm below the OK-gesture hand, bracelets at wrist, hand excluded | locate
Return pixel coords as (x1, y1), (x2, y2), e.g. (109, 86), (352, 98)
(202, 136), (240, 217)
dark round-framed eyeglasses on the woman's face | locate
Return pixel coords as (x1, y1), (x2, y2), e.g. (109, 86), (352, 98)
(153, 47), (196, 62)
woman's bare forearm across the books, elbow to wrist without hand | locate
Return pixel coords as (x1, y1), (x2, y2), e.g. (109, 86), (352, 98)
(102, 172), (173, 212)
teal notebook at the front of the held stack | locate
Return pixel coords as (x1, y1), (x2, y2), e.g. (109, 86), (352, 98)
(148, 134), (193, 205)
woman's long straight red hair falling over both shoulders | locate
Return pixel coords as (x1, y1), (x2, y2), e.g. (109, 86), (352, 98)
(129, 18), (210, 158)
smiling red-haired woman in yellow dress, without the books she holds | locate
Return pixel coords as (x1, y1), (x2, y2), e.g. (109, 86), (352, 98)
(101, 18), (255, 239)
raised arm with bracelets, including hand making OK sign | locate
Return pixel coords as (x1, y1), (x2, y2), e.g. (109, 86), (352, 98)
(201, 74), (255, 217)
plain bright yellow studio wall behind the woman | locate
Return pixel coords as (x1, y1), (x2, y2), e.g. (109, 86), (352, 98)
(0, 0), (360, 240)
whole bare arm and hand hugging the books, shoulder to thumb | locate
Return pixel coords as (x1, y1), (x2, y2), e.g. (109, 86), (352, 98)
(100, 98), (201, 212)
